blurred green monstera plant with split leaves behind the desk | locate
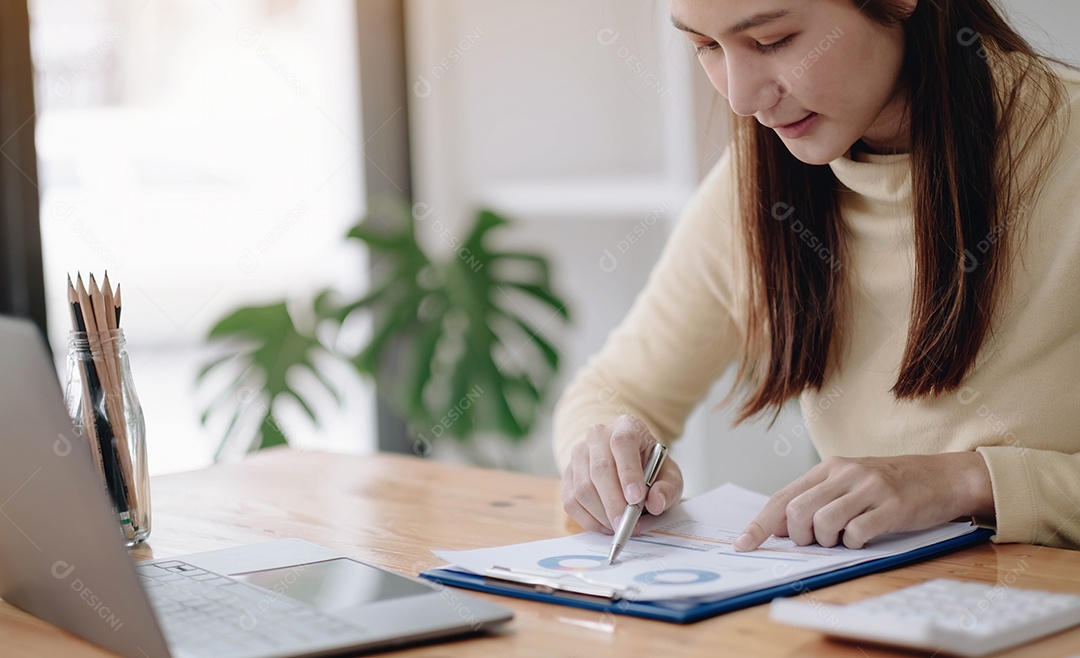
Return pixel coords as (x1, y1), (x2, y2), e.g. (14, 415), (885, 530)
(198, 203), (569, 464)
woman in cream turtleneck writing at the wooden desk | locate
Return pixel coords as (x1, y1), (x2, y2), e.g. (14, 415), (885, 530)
(555, 0), (1080, 550)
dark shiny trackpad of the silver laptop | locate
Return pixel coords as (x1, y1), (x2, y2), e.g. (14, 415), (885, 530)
(229, 558), (432, 616)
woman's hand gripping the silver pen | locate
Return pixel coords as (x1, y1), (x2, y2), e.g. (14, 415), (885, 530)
(563, 416), (683, 535)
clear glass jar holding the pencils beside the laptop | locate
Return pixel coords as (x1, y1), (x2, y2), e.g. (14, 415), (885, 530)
(64, 328), (150, 546)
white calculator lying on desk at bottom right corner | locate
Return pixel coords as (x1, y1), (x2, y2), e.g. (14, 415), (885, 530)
(769, 578), (1080, 656)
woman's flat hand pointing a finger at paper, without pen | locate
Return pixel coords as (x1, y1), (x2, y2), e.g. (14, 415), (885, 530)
(734, 452), (994, 551)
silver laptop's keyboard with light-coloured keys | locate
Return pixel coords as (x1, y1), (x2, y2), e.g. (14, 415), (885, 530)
(137, 560), (364, 658)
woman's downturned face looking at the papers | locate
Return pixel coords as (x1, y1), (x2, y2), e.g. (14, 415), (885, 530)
(671, 0), (917, 164)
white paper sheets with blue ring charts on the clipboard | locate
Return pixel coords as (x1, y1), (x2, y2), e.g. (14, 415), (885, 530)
(435, 484), (974, 601)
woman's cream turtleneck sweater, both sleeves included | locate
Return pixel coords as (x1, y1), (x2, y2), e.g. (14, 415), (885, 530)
(554, 66), (1080, 548)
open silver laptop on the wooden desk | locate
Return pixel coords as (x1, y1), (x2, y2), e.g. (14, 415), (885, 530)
(0, 318), (512, 658)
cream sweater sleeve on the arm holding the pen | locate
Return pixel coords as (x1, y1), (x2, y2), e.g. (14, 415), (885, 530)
(553, 153), (743, 470)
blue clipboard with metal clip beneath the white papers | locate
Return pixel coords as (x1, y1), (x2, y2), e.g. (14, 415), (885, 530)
(420, 527), (994, 623)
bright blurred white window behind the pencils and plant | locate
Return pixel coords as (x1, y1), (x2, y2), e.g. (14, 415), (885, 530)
(30, 0), (372, 473)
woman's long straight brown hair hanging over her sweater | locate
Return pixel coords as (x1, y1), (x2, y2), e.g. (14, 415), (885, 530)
(732, 0), (1065, 421)
